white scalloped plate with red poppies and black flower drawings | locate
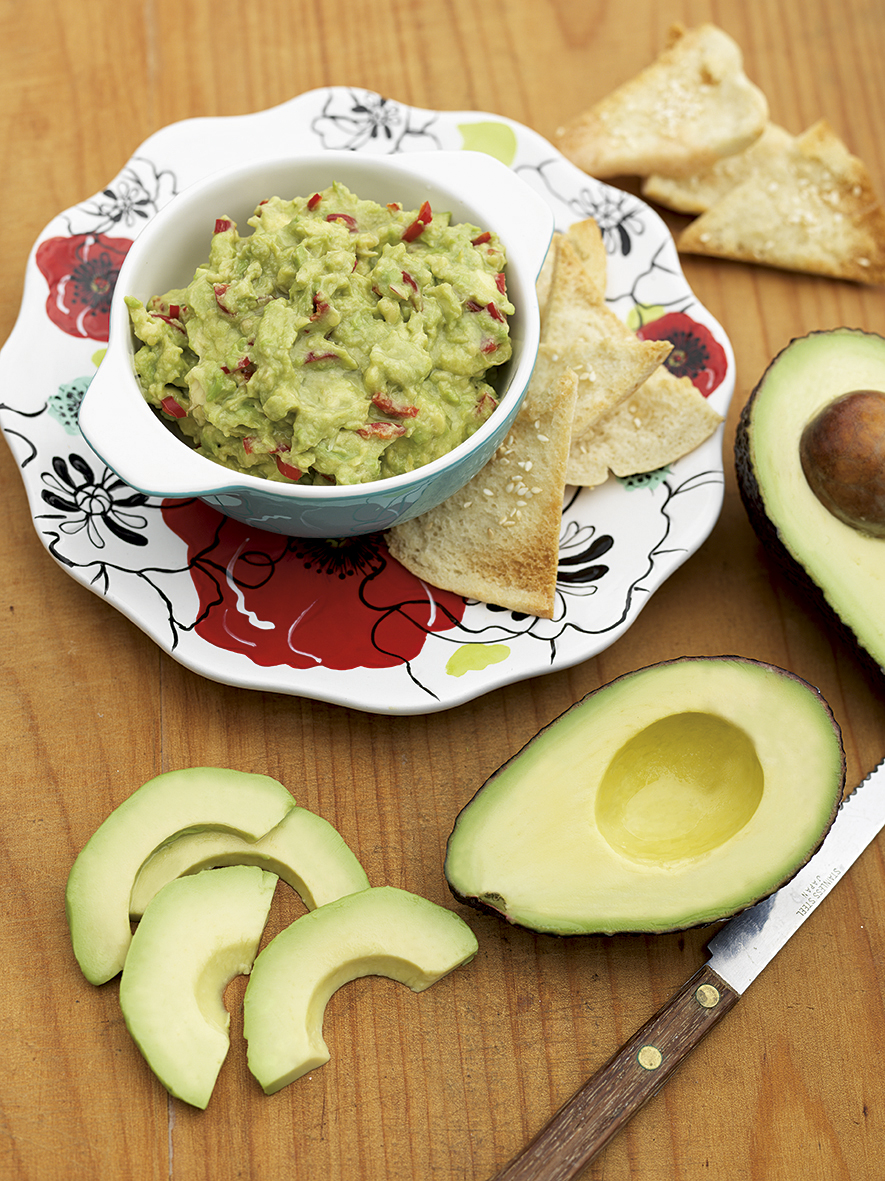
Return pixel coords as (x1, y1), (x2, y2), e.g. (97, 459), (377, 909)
(0, 87), (734, 715)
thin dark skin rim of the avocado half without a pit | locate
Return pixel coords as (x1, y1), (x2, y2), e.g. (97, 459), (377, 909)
(445, 654), (847, 939)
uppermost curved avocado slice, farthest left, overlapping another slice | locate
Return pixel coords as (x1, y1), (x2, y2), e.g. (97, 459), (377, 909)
(65, 766), (295, 984)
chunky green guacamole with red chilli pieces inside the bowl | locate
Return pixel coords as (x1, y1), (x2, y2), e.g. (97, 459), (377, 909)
(126, 184), (514, 484)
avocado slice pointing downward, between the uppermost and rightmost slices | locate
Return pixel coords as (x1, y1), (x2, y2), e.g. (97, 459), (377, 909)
(119, 866), (276, 1108)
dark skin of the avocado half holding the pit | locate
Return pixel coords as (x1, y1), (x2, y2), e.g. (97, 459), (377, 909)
(734, 328), (885, 678)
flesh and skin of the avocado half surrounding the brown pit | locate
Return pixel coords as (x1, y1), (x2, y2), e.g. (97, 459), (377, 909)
(735, 328), (885, 670)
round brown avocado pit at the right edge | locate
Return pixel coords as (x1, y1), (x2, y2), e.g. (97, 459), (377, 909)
(799, 390), (885, 537)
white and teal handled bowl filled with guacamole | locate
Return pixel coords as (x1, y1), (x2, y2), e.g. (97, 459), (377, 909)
(80, 151), (553, 537)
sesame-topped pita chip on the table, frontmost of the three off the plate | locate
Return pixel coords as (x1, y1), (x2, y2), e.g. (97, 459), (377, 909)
(677, 119), (885, 283)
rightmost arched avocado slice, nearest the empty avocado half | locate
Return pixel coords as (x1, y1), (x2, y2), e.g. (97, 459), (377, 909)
(243, 886), (477, 1095)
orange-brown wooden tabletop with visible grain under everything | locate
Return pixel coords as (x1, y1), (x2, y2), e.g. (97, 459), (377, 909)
(0, 0), (885, 1181)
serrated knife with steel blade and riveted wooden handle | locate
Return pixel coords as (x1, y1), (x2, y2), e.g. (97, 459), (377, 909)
(492, 759), (885, 1181)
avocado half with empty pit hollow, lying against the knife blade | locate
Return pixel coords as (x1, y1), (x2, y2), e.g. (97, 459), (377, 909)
(445, 657), (845, 935)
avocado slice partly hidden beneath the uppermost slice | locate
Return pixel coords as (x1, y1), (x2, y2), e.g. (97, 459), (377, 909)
(129, 807), (369, 919)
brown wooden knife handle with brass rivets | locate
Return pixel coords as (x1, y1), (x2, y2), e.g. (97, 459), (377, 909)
(493, 966), (740, 1181)
